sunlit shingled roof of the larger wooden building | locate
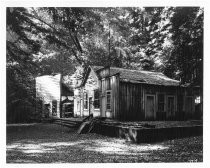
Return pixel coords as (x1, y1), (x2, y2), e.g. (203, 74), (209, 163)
(92, 66), (180, 86)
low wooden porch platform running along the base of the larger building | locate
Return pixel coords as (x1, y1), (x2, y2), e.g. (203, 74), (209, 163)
(50, 117), (203, 143)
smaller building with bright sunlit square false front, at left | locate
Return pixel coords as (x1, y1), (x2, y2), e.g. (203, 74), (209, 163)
(35, 74), (74, 118)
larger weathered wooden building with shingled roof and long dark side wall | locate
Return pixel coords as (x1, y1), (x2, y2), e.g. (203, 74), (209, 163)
(74, 66), (202, 120)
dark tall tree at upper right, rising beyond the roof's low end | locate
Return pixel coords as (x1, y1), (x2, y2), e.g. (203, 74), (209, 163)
(171, 7), (203, 85)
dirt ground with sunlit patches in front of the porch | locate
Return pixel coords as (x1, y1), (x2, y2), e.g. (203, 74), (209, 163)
(7, 124), (203, 163)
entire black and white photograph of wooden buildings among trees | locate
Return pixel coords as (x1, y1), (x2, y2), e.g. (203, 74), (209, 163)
(2, 2), (206, 166)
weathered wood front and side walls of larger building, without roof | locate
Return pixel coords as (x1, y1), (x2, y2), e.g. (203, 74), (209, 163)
(75, 68), (202, 121)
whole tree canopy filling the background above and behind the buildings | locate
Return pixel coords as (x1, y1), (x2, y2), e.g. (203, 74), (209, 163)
(6, 7), (204, 122)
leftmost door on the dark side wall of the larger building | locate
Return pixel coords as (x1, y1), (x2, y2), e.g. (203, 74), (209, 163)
(146, 95), (155, 119)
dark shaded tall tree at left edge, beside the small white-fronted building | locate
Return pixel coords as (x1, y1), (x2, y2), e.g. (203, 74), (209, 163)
(6, 8), (40, 121)
